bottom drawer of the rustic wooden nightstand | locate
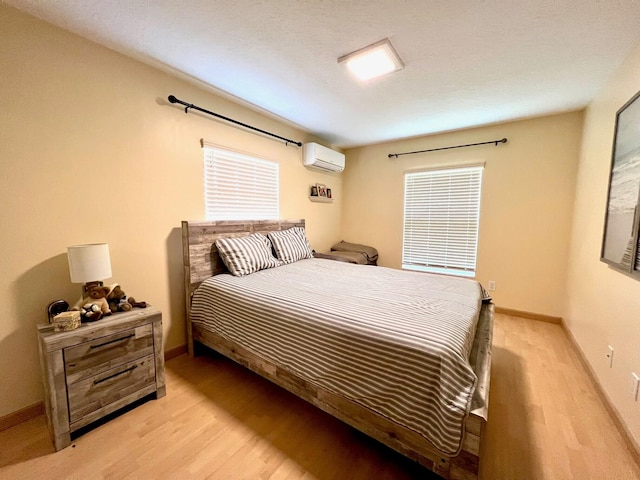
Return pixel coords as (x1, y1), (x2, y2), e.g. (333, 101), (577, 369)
(68, 355), (156, 423)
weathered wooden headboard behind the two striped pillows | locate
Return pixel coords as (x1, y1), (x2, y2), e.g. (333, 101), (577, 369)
(182, 220), (305, 353)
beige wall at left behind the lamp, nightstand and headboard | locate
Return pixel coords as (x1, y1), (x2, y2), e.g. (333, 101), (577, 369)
(0, 5), (342, 416)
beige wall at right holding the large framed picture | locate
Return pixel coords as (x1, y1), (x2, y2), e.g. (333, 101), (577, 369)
(564, 40), (640, 444)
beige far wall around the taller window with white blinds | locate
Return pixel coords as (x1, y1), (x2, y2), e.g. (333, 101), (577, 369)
(342, 112), (582, 316)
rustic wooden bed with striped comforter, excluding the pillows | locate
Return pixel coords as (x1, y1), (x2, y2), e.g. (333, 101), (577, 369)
(182, 220), (493, 479)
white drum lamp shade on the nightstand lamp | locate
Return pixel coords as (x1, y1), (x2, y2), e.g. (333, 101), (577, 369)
(67, 243), (111, 283)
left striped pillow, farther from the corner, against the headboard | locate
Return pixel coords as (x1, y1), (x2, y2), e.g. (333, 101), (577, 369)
(216, 233), (282, 277)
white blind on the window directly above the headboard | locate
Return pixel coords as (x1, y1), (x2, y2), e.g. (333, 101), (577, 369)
(203, 146), (280, 220)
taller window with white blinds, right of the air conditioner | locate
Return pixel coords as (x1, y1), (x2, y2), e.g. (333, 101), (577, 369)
(402, 166), (483, 277)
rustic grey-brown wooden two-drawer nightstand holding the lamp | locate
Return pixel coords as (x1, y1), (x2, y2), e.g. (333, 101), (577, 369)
(38, 306), (166, 450)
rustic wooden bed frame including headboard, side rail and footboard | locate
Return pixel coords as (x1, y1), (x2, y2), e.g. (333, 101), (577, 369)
(182, 220), (493, 480)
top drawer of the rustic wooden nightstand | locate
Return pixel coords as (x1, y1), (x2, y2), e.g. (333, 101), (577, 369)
(64, 324), (153, 384)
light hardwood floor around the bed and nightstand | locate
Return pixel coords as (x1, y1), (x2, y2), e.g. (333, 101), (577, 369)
(0, 314), (640, 480)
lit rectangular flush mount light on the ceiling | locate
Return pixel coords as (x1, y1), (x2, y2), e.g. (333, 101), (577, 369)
(338, 38), (404, 81)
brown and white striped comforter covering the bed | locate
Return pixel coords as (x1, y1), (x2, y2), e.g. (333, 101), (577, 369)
(191, 259), (482, 455)
